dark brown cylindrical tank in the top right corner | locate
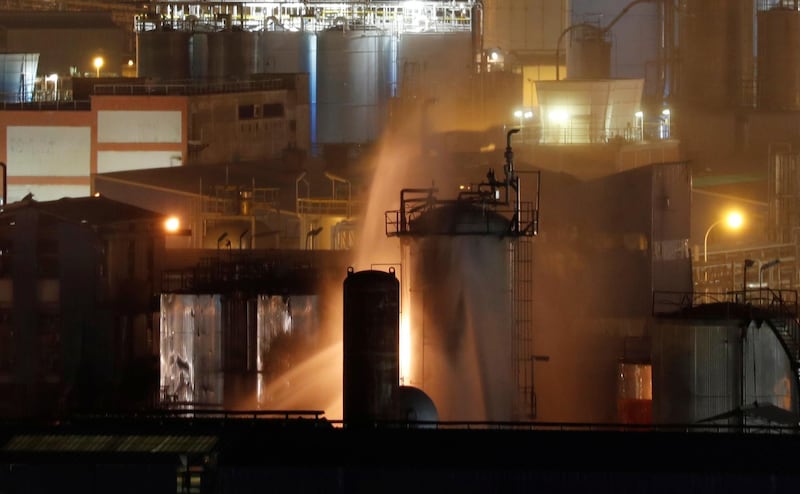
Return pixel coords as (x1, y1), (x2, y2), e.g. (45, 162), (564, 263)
(757, 9), (800, 111)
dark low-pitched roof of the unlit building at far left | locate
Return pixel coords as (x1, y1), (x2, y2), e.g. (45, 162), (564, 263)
(2, 196), (163, 225)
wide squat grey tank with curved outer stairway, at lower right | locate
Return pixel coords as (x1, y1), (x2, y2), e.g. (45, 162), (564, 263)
(651, 307), (797, 424)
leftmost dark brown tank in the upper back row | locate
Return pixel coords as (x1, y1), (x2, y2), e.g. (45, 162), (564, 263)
(136, 31), (192, 81)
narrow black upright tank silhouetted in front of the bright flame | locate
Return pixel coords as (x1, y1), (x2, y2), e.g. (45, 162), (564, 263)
(342, 268), (400, 425)
